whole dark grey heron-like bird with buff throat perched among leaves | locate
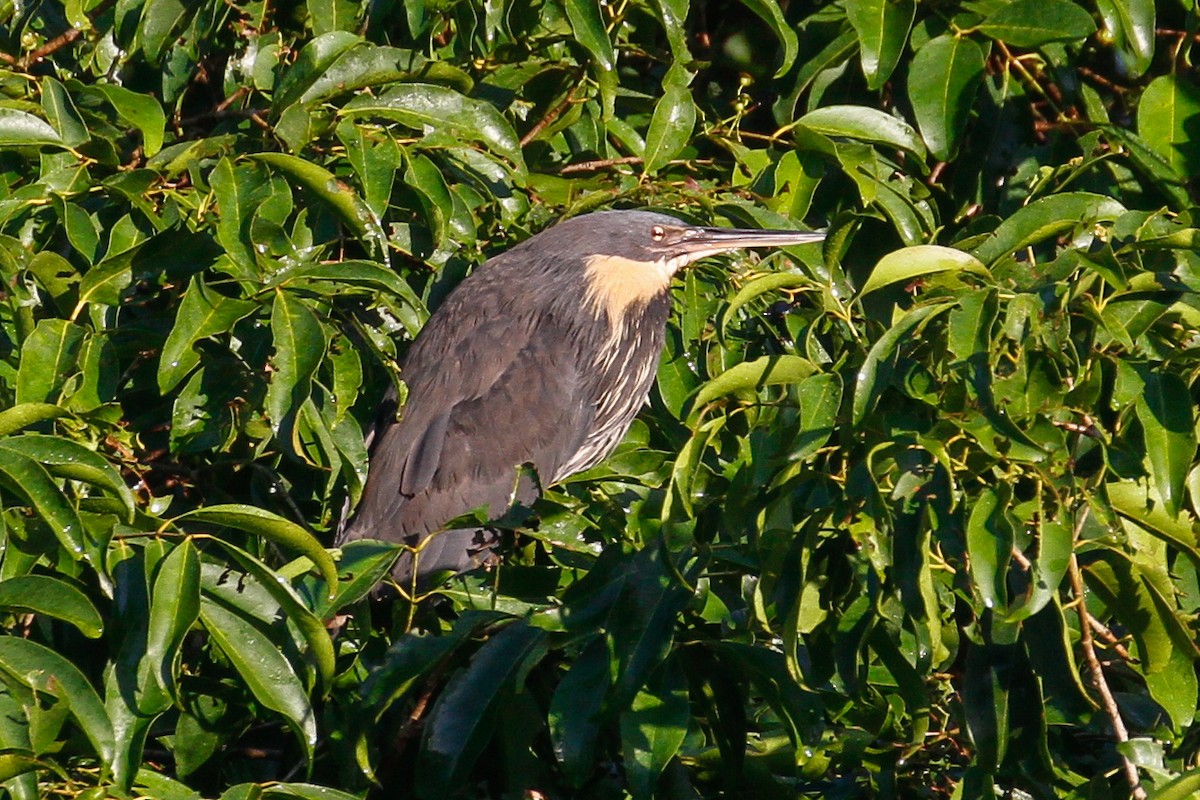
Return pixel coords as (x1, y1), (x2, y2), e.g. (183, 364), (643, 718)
(337, 210), (824, 590)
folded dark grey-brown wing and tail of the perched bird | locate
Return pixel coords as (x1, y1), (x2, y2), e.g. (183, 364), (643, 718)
(343, 315), (595, 581)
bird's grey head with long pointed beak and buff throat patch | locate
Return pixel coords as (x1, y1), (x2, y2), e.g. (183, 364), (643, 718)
(530, 211), (824, 325)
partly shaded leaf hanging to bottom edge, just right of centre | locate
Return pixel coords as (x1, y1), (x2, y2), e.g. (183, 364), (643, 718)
(620, 661), (691, 798)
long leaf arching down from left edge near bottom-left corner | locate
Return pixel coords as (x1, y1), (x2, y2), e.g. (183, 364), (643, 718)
(0, 636), (115, 765)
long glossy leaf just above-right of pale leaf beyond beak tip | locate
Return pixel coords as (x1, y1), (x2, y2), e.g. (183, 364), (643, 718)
(974, 192), (1126, 266)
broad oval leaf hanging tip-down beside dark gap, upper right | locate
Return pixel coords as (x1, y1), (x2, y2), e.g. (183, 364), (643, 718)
(907, 35), (984, 161)
